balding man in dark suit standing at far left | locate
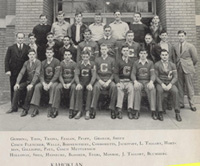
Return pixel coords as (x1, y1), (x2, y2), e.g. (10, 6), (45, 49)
(5, 32), (30, 113)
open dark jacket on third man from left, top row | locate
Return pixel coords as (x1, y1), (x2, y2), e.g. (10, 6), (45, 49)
(70, 24), (87, 45)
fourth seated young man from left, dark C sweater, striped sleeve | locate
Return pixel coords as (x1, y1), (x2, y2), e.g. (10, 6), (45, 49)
(75, 50), (96, 120)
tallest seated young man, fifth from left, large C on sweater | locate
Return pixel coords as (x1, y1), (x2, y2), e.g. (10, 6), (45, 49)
(91, 44), (117, 119)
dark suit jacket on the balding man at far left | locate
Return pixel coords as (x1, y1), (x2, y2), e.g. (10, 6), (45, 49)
(5, 44), (30, 76)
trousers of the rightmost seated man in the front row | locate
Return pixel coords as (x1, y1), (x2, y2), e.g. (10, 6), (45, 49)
(156, 84), (180, 113)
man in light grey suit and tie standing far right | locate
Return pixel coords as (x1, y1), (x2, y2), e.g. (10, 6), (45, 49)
(174, 30), (198, 111)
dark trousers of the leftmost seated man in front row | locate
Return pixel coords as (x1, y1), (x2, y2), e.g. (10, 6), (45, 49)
(12, 82), (34, 111)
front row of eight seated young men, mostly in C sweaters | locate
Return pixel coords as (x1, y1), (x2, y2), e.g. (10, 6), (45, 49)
(9, 44), (182, 121)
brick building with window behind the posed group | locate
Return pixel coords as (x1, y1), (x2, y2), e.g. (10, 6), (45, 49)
(0, 0), (200, 99)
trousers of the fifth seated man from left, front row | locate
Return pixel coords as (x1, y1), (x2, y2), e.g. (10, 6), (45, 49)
(91, 82), (117, 110)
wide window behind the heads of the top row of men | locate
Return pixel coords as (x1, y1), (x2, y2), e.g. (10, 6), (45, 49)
(54, 0), (156, 24)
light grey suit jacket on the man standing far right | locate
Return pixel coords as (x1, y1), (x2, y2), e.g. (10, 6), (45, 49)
(173, 42), (198, 74)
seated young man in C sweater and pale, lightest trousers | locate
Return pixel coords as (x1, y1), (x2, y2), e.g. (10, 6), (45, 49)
(115, 45), (134, 119)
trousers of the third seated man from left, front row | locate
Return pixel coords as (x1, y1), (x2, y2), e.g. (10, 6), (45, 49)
(52, 83), (76, 110)
